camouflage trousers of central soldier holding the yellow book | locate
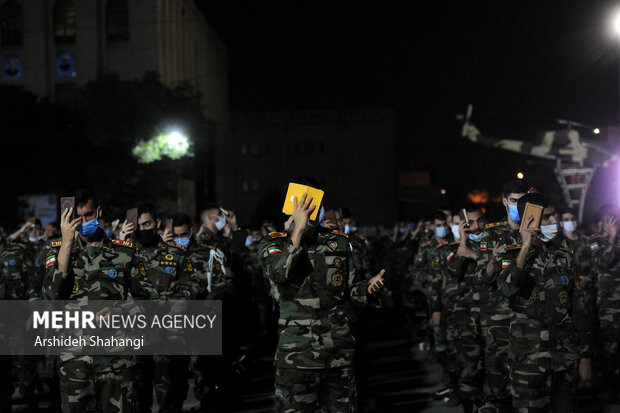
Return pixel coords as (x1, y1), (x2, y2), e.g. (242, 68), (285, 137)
(276, 367), (357, 413)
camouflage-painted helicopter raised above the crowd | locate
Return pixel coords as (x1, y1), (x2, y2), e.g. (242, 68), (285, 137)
(457, 104), (620, 221)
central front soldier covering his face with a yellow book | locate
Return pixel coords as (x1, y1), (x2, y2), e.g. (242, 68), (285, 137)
(260, 183), (383, 413)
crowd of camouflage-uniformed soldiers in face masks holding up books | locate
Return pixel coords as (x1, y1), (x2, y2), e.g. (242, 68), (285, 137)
(0, 180), (620, 412)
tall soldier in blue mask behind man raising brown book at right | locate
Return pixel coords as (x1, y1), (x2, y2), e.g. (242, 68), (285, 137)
(476, 180), (530, 413)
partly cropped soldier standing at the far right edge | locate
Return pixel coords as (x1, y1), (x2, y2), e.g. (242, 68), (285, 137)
(589, 206), (620, 402)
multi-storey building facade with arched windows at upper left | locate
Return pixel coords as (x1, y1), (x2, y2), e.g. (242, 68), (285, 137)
(0, 0), (229, 217)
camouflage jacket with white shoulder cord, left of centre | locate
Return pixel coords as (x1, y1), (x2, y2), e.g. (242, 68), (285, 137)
(187, 241), (232, 300)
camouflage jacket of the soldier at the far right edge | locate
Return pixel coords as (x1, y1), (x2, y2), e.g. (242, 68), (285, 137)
(589, 233), (620, 324)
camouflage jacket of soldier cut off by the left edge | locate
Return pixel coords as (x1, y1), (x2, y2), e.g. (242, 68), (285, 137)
(0, 241), (36, 300)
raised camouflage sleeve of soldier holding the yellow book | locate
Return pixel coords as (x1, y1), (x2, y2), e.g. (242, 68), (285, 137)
(259, 237), (311, 286)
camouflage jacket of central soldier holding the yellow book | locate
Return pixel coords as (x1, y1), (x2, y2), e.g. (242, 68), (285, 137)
(260, 227), (368, 369)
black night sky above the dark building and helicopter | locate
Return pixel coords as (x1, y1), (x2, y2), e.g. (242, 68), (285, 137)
(202, 0), (620, 217)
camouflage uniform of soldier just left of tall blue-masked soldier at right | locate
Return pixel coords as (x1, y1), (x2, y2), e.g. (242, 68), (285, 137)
(446, 239), (484, 399)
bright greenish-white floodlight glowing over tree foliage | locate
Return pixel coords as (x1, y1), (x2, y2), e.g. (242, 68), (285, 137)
(132, 131), (194, 163)
